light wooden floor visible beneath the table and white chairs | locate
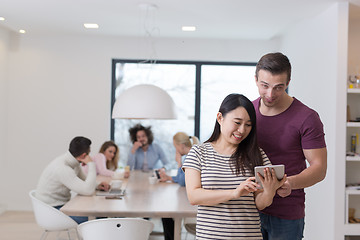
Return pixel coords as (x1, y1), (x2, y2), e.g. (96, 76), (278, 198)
(0, 211), (195, 240)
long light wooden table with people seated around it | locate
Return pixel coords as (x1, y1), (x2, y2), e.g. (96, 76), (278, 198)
(60, 170), (197, 240)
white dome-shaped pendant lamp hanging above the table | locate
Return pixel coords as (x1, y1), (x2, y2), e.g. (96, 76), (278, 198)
(112, 84), (176, 119)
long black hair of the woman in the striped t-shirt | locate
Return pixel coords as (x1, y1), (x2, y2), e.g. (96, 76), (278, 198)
(205, 94), (263, 175)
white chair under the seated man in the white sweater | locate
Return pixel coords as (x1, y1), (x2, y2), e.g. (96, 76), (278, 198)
(29, 190), (80, 239)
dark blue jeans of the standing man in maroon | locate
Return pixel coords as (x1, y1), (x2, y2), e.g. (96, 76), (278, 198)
(260, 213), (305, 240)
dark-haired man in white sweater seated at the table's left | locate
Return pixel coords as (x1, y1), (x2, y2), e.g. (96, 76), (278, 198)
(36, 137), (109, 224)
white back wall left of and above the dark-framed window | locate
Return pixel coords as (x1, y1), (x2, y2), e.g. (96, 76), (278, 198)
(0, 29), (278, 210)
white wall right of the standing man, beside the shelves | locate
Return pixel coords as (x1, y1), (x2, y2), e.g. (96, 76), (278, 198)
(282, 3), (348, 240)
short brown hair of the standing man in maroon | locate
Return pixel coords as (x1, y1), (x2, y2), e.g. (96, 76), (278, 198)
(255, 52), (291, 83)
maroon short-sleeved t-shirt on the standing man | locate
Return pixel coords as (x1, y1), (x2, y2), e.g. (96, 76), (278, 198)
(253, 98), (326, 219)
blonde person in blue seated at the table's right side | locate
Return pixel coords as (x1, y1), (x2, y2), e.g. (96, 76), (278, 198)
(159, 132), (199, 187)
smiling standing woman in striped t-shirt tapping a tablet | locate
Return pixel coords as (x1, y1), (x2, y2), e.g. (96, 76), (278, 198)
(183, 94), (286, 240)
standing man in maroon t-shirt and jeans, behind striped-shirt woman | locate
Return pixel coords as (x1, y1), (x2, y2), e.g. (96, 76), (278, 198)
(253, 53), (327, 240)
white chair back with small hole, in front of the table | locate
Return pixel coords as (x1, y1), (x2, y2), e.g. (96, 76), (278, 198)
(78, 218), (154, 240)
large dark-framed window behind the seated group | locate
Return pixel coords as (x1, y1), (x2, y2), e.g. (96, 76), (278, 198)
(111, 60), (258, 168)
